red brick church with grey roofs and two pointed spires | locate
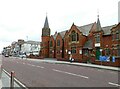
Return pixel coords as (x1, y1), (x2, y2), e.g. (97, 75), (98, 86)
(40, 16), (120, 66)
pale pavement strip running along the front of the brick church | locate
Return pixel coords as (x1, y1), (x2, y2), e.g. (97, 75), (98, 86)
(27, 58), (120, 71)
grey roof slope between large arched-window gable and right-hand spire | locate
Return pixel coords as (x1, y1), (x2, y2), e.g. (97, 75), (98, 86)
(77, 23), (94, 36)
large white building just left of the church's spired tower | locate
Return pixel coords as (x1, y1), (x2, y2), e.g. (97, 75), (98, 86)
(21, 41), (40, 55)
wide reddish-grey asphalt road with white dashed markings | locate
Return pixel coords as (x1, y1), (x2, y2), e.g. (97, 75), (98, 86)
(2, 57), (120, 87)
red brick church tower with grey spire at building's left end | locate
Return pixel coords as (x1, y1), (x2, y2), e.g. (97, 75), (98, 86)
(41, 16), (50, 58)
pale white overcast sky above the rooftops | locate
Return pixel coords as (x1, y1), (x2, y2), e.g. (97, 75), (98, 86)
(0, 0), (120, 51)
